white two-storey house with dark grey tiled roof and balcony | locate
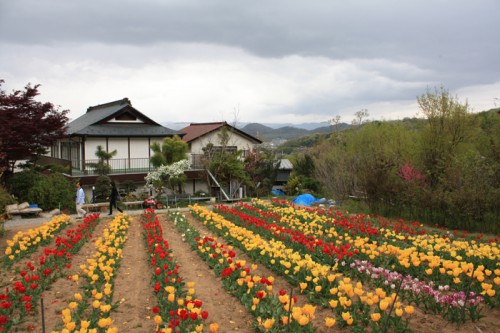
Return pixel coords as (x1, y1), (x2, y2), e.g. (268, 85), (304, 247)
(48, 98), (184, 185)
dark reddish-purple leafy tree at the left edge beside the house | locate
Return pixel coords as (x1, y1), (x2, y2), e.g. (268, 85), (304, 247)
(0, 80), (69, 179)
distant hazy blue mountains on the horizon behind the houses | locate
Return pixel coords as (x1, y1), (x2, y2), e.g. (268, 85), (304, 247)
(162, 122), (350, 142)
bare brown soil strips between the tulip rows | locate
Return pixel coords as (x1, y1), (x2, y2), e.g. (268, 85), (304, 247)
(0, 213), (500, 333)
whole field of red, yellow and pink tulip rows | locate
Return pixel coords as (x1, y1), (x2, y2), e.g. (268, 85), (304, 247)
(0, 199), (500, 333)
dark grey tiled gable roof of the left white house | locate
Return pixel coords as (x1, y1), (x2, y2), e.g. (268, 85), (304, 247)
(68, 98), (184, 137)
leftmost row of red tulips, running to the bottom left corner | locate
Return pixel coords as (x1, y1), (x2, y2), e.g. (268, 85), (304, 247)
(0, 214), (99, 332)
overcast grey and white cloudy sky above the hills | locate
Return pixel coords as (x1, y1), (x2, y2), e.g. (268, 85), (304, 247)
(0, 0), (500, 124)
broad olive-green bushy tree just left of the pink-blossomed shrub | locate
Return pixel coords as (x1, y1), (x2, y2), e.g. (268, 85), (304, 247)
(310, 121), (416, 206)
